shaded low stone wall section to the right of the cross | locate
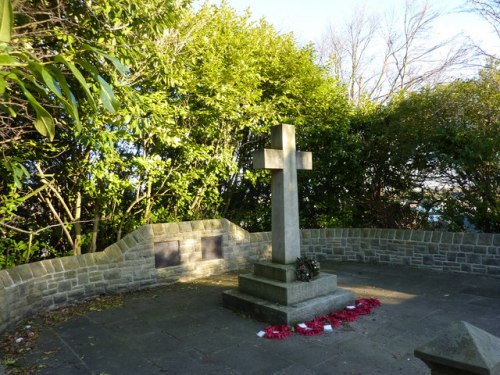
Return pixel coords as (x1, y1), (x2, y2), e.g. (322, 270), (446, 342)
(301, 228), (500, 277)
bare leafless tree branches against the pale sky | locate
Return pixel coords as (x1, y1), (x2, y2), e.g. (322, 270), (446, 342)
(320, 0), (480, 103)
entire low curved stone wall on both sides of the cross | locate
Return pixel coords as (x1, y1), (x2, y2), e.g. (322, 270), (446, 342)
(0, 219), (500, 332)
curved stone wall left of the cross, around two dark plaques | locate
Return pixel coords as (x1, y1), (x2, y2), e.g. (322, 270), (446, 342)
(0, 219), (271, 333)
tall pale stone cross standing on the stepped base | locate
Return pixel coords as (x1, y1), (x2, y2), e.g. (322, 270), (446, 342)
(253, 124), (312, 264)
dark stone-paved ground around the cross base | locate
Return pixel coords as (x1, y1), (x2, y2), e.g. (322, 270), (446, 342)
(3, 264), (500, 375)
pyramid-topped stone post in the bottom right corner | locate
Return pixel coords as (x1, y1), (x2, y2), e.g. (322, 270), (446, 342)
(415, 321), (500, 375)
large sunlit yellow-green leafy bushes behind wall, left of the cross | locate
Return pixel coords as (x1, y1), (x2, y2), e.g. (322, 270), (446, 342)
(1, 0), (352, 266)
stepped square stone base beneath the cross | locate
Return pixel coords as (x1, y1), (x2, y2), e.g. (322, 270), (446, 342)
(222, 262), (354, 325)
